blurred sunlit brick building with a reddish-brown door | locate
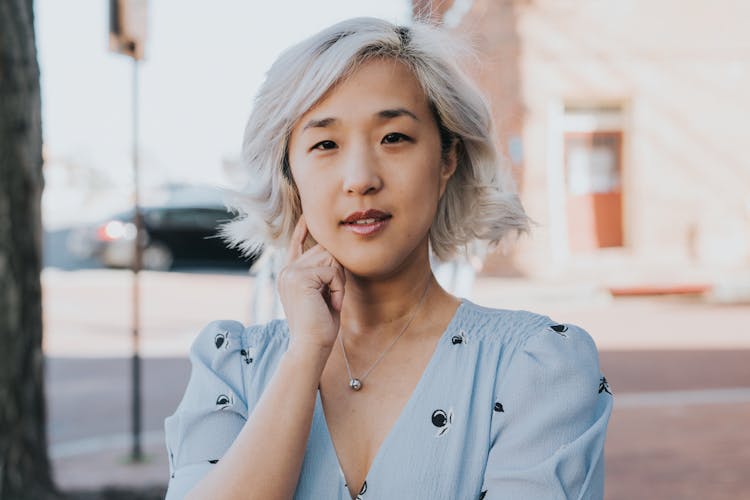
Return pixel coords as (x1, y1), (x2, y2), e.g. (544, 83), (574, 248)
(412, 0), (750, 285)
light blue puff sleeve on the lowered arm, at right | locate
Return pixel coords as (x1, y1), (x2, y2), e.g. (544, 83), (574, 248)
(480, 322), (613, 500)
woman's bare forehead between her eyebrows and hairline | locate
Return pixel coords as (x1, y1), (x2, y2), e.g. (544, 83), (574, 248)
(295, 58), (430, 129)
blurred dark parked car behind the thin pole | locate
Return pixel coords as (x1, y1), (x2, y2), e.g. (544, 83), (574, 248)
(68, 206), (258, 270)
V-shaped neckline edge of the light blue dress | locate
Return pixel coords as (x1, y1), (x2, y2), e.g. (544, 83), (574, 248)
(315, 298), (469, 498)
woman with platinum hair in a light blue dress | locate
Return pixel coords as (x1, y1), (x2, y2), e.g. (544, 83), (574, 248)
(166, 18), (612, 500)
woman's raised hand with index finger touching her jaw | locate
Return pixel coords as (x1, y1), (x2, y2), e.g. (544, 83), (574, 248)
(278, 215), (346, 351)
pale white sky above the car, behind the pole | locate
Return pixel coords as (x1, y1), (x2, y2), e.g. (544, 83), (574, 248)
(35, 0), (411, 189)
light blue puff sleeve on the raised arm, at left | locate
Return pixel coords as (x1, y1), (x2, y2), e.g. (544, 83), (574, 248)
(164, 321), (248, 500)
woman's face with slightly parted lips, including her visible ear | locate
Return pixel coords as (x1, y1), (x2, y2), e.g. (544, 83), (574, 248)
(289, 59), (455, 277)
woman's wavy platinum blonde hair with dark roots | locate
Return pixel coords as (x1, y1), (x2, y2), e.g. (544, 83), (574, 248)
(219, 17), (530, 260)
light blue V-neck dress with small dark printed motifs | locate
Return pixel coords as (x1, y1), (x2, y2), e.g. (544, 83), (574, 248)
(165, 299), (612, 500)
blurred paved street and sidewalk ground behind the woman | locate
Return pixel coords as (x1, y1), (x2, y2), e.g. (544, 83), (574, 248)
(43, 269), (750, 500)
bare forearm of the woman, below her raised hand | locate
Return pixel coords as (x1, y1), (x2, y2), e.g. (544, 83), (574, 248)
(187, 347), (330, 500)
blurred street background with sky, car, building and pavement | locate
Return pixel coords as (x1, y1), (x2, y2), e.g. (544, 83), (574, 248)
(17, 0), (750, 499)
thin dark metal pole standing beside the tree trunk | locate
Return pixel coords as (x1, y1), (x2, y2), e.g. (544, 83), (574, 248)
(130, 57), (143, 462)
